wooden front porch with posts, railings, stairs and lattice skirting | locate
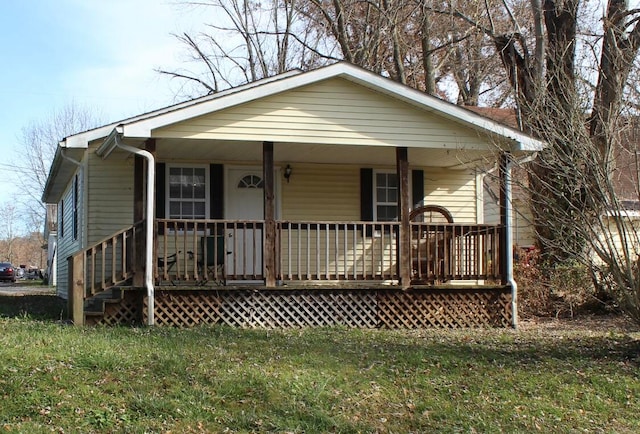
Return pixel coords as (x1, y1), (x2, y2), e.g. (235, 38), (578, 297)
(70, 143), (514, 327)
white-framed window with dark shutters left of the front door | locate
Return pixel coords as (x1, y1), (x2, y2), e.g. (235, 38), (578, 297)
(167, 166), (208, 219)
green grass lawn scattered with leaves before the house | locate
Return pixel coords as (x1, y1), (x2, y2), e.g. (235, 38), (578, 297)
(0, 296), (640, 433)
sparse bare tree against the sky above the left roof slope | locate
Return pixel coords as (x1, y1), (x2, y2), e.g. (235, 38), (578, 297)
(157, 0), (322, 97)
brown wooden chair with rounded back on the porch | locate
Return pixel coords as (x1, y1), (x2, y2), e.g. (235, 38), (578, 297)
(409, 205), (453, 282)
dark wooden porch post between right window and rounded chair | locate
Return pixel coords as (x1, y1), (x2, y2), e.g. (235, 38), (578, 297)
(396, 147), (411, 289)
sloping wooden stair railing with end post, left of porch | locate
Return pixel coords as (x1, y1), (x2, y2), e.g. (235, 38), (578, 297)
(68, 221), (144, 324)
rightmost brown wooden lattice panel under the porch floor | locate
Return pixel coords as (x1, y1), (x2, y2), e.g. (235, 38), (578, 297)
(378, 289), (511, 328)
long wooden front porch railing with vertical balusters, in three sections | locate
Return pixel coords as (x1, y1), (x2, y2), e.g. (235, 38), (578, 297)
(155, 219), (502, 285)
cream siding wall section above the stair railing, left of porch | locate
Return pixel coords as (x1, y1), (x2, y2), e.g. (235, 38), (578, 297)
(86, 145), (134, 246)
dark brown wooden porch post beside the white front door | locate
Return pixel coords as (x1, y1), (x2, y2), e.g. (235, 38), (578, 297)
(262, 142), (276, 288)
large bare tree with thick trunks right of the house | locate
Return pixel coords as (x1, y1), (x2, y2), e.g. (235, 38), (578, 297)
(457, 0), (640, 322)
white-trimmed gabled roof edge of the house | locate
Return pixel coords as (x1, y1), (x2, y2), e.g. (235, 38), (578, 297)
(43, 62), (544, 202)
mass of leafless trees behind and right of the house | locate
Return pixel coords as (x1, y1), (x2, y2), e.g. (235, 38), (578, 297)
(164, 0), (640, 318)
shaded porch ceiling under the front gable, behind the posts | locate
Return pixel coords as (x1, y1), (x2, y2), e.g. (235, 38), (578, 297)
(156, 139), (495, 168)
